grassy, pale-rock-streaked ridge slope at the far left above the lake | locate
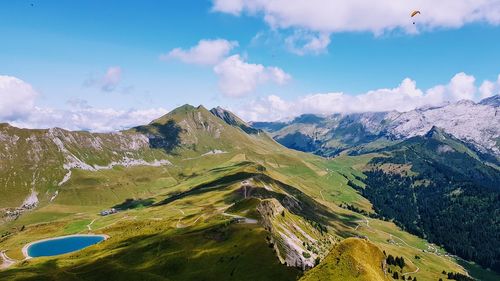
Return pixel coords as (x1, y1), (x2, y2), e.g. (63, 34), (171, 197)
(0, 124), (166, 208)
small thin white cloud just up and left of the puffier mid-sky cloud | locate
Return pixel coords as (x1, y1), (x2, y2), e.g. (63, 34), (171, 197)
(160, 39), (238, 65)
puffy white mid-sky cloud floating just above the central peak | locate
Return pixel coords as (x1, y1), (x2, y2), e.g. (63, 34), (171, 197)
(214, 55), (291, 97)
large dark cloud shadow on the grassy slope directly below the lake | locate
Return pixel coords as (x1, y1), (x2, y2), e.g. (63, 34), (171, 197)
(0, 220), (300, 281)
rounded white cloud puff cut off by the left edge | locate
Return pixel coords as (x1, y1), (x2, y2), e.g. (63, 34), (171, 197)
(0, 75), (38, 118)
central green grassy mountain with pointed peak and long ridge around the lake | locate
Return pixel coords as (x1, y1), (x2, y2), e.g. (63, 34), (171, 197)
(0, 106), (482, 280)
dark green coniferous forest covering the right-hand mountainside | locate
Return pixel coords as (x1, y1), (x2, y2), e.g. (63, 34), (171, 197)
(351, 132), (500, 272)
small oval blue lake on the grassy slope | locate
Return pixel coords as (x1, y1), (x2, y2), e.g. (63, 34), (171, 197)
(28, 235), (104, 257)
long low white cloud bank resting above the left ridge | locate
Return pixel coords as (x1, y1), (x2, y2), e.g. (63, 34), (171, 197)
(0, 75), (168, 132)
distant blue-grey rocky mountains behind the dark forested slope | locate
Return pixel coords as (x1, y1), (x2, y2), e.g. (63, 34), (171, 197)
(251, 95), (500, 161)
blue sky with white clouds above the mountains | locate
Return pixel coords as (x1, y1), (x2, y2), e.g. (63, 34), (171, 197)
(0, 0), (500, 131)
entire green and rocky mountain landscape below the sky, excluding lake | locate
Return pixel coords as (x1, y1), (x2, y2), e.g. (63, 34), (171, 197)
(0, 96), (500, 280)
